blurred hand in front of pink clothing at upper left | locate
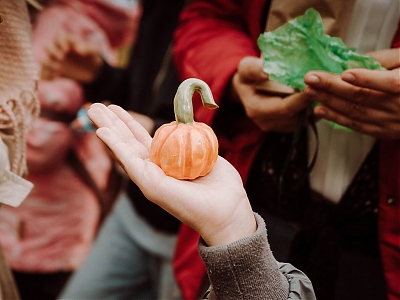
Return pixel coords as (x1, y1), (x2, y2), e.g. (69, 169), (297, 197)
(40, 33), (104, 83)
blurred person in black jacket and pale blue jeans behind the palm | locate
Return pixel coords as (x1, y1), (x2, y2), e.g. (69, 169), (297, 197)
(43, 0), (185, 299)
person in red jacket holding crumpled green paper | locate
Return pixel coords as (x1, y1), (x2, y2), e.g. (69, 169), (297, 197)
(174, 0), (400, 299)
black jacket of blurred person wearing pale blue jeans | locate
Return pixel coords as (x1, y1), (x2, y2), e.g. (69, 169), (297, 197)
(85, 0), (185, 233)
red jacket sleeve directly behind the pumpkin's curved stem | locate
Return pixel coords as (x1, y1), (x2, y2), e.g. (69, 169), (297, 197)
(174, 0), (259, 124)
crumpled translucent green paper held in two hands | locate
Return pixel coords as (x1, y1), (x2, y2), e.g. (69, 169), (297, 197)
(257, 8), (384, 130)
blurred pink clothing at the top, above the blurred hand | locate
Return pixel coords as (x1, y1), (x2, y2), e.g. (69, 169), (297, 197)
(33, 0), (141, 65)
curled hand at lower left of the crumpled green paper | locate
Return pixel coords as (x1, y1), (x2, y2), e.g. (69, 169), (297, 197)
(231, 56), (312, 132)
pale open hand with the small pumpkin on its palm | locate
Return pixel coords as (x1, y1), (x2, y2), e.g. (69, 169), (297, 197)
(88, 103), (256, 246)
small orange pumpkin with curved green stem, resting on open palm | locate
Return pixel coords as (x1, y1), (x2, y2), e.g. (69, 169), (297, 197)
(149, 78), (218, 180)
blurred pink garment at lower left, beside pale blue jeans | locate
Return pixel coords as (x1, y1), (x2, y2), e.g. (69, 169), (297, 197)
(0, 165), (99, 272)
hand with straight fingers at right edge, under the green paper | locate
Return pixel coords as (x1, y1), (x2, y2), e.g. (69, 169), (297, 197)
(304, 48), (400, 139)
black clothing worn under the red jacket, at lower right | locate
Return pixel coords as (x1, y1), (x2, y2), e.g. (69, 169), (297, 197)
(246, 131), (386, 300)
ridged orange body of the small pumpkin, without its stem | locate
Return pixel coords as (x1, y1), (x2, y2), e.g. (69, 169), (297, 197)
(150, 121), (218, 179)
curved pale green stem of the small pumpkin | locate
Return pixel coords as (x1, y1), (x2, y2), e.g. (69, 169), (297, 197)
(174, 78), (218, 124)
